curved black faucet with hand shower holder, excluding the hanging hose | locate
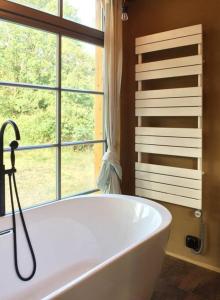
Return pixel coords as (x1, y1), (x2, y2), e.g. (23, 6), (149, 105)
(0, 120), (20, 216)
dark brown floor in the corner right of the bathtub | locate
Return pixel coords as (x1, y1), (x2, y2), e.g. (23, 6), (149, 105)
(152, 256), (220, 300)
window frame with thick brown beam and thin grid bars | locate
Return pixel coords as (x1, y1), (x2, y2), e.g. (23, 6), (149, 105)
(0, 0), (106, 206)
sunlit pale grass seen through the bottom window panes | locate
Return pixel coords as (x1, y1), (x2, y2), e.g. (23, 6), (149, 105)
(5, 147), (96, 211)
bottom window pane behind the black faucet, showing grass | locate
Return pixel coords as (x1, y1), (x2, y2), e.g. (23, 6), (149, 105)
(4, 148), (56, 212)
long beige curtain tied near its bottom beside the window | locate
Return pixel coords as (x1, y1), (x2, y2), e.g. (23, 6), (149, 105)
(98, 0), (122, 194)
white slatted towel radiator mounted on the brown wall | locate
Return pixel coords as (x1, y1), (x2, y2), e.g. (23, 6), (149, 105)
(135, 25), (203, 209)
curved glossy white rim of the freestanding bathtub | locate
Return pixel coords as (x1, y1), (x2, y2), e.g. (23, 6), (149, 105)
(42, 194), (172, 300)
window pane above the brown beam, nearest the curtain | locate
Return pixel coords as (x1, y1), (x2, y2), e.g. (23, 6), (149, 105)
(63, 0), (102, 30)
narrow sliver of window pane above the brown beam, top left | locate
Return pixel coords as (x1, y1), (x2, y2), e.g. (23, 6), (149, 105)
(10, 0), (58, 15)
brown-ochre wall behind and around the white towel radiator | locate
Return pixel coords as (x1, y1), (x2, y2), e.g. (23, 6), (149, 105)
(121, 0), (220, 271)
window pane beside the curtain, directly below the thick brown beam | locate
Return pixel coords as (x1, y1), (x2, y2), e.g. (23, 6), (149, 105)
(62, 37), (103, 91)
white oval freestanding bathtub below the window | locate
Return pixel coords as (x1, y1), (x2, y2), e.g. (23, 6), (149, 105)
(0, 195), (171, 300)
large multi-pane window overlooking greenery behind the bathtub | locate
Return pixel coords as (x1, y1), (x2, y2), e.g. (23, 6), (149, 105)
(0, 0), (105, 211)
